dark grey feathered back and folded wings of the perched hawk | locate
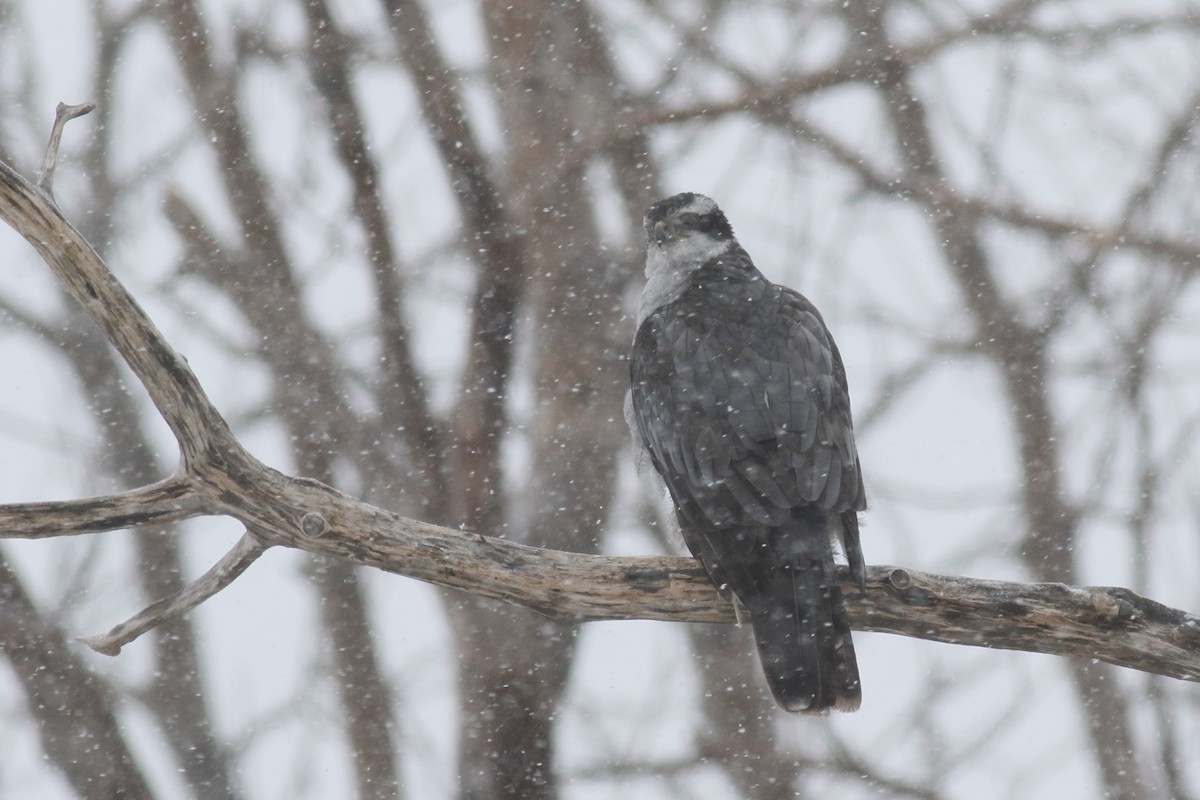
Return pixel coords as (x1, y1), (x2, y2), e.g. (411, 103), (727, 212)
(631, 262), (865, 528)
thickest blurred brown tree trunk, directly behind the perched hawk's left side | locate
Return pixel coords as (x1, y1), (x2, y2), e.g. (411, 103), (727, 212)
(452, 2), (628, 798)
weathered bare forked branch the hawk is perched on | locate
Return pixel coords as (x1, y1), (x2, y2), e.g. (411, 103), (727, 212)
(0, 123), (1200, 681)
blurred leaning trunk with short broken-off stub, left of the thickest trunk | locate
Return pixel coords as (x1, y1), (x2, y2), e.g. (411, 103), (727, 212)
(160, 0), (402, 800)
